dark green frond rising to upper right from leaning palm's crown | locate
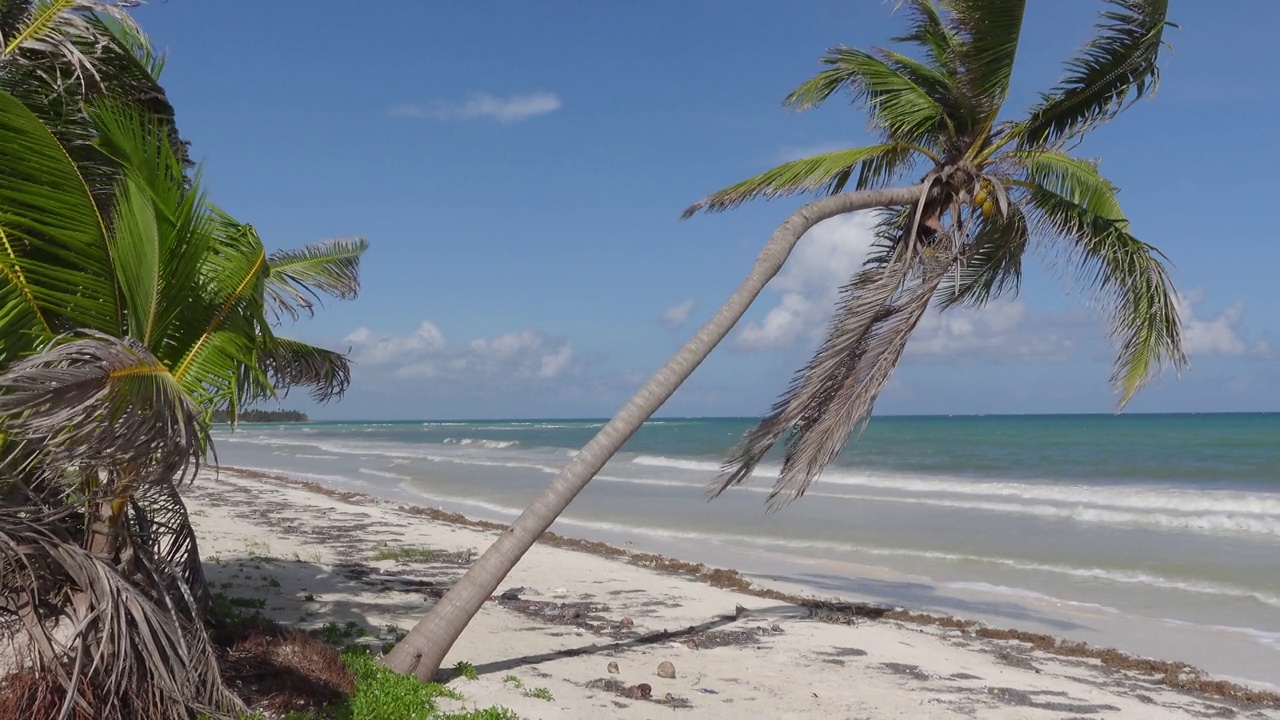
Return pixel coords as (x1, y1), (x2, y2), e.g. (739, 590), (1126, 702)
(1011, 0), (1176, 147)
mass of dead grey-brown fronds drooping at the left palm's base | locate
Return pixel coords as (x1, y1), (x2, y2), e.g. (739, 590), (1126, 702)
(0, 507), (244, 720)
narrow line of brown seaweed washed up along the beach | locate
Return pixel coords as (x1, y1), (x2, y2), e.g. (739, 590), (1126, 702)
(212, 466), (1280, 708)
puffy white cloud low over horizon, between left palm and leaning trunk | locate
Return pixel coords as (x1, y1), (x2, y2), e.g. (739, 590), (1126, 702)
(346, 320), (579, 387)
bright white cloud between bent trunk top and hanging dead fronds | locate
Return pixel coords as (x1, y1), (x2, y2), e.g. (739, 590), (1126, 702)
(733, 213), (876, 350)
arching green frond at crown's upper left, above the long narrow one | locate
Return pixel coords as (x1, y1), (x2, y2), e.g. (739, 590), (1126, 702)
(783, 47), (954, 145)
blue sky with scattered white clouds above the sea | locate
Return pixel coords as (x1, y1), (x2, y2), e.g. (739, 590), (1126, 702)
(136, 0), (1280, 420)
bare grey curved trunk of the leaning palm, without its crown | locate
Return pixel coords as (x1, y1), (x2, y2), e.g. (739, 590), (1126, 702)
(384, 184), (924, 682)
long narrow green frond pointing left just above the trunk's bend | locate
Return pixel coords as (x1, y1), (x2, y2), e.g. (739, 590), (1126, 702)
(681, 142), (911, 218)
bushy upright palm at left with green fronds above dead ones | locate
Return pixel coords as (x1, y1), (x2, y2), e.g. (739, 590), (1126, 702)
(0, 91), (365, 717)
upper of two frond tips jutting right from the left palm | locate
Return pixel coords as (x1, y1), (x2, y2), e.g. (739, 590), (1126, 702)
(265, 237), (369, 320)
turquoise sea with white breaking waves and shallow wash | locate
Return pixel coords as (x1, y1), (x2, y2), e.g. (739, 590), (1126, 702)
(215, 414), (1280, 688)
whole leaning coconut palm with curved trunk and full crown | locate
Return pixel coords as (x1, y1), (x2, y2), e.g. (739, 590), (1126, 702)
(387, 0), (1185, 678)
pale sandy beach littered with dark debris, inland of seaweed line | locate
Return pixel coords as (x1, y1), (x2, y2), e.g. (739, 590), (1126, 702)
(184, 469), (1280, 720)
